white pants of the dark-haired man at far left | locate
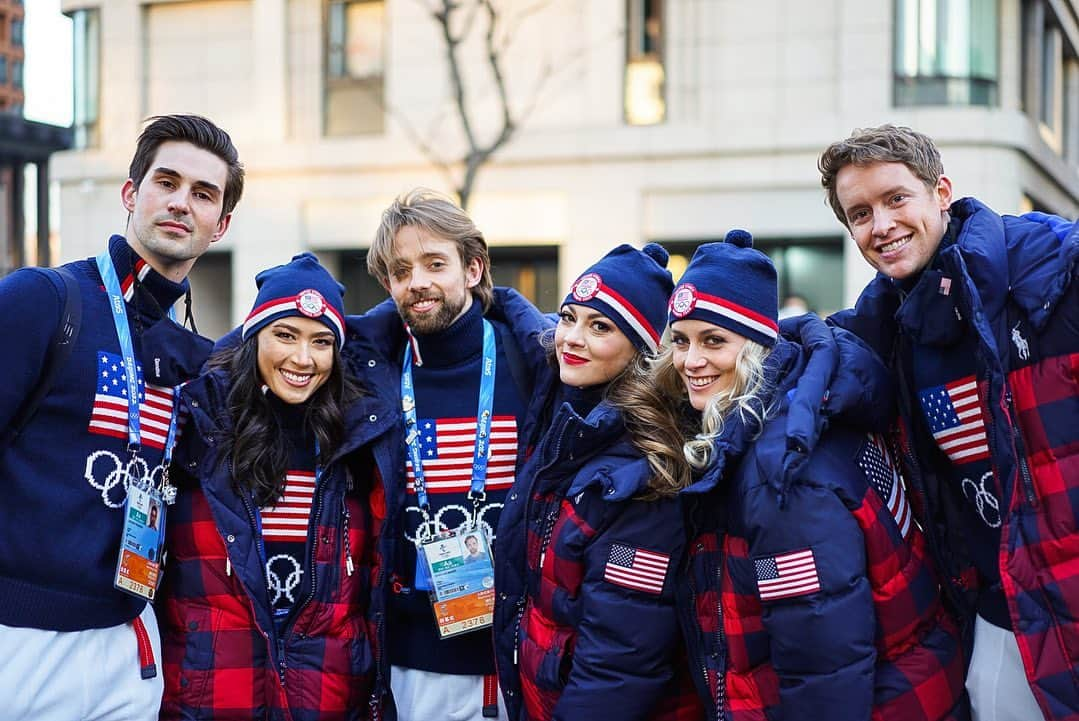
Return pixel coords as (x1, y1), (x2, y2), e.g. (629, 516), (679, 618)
(0, 603), (163, 721)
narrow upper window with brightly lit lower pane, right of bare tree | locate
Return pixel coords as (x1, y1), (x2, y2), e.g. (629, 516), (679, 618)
(624, 0), (667, 125)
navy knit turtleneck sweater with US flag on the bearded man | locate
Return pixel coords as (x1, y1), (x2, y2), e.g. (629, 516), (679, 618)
(388, 303), (525, 675)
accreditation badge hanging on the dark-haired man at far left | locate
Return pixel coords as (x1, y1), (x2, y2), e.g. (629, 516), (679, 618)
(112, 486), (165, 601)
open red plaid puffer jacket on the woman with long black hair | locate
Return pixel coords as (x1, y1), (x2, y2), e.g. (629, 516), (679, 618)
(156, 376), (397, 721)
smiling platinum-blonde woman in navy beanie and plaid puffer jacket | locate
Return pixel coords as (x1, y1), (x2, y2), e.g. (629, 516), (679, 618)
(656, 231), (968, 721)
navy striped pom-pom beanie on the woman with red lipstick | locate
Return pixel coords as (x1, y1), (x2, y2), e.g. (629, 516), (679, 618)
(562, 243), (674, 353)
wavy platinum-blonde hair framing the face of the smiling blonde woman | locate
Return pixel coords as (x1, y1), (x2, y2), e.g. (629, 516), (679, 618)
(652, 339), (771, 471)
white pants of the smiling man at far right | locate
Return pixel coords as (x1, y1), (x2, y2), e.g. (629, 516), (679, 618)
(967, 616), (1043, 721)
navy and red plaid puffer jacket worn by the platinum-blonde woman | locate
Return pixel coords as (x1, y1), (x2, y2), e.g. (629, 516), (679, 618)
(679, 334), (969, 721)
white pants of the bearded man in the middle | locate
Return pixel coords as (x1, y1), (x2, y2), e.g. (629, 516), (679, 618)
(390, 666), (506, 721)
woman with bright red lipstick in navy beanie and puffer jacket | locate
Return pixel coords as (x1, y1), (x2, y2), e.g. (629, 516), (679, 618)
(494, 244), (700, 721)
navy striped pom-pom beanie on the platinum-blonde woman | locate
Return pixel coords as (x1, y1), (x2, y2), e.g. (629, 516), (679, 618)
(669, 230), (779, 348)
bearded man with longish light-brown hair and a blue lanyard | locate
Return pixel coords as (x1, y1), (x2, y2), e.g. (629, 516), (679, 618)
(344, 190), (552, 721)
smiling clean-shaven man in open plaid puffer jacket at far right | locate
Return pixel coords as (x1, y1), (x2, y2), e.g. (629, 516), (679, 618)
(819, 125), (1079, 721)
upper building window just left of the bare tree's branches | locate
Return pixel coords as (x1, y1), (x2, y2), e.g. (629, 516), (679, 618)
(324, 0), (385, 135)
